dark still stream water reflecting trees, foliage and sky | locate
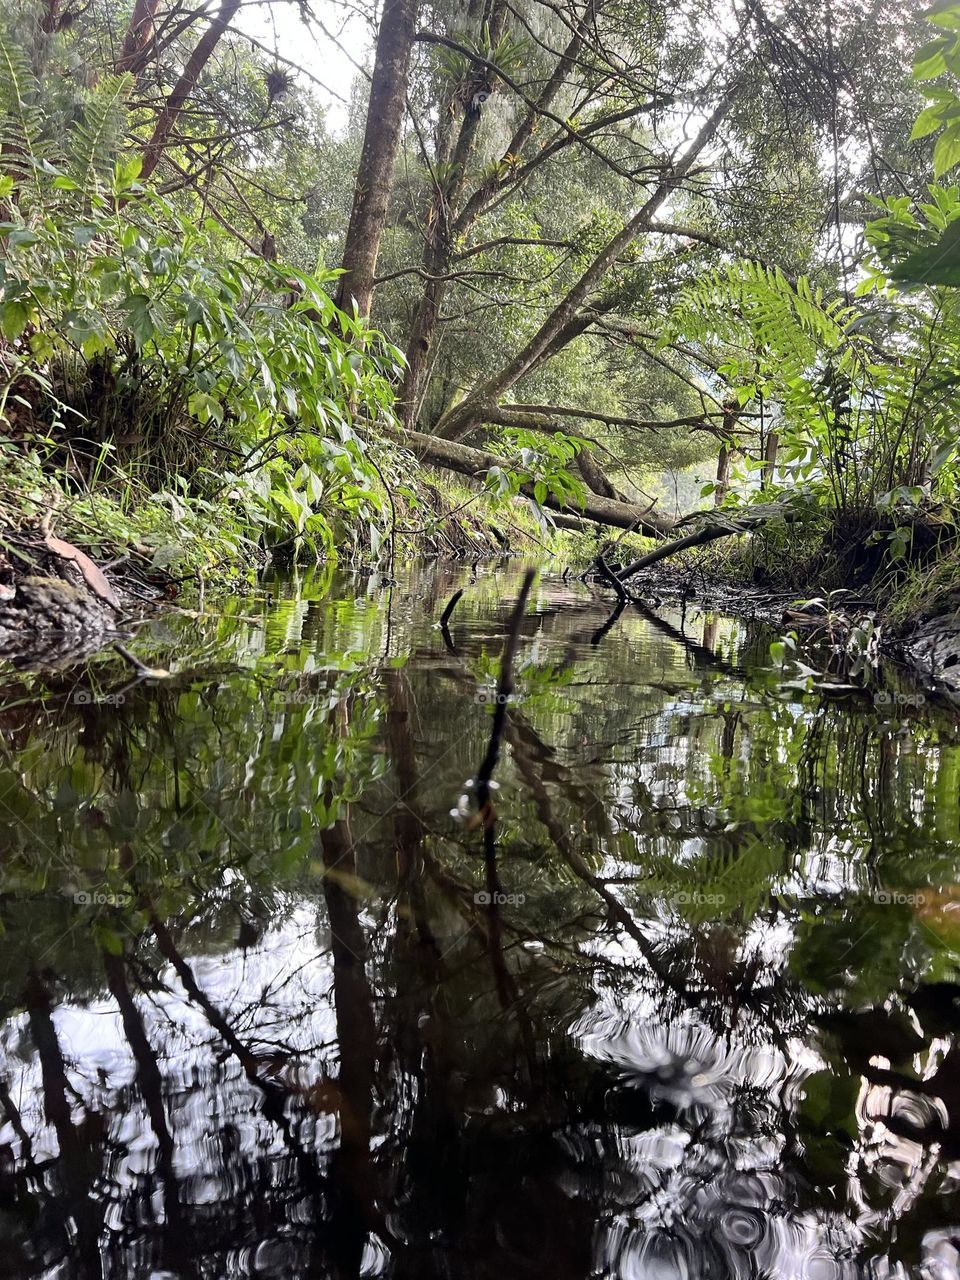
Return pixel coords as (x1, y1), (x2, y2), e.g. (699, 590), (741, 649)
(0, 568), (960, 1280)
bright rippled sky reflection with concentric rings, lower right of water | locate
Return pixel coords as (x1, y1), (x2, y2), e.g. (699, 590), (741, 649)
(575, 991), (901, 1280)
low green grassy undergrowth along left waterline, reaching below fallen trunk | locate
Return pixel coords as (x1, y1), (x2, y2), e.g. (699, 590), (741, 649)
(0, 444), (550, 589)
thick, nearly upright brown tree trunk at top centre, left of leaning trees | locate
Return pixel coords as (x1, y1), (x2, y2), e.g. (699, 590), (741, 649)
(337, 0), (417, 317)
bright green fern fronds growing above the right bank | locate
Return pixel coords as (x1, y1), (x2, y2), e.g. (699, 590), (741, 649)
(663, 241), (960, 542)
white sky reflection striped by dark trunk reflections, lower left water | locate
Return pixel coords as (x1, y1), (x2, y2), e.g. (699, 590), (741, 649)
(0, 902), (337, 1182)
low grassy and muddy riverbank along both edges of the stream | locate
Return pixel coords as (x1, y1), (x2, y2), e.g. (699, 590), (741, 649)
(9, 453), (960, 699)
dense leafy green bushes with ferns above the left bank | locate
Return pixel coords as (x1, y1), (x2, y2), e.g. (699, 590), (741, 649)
(0, 18), (399, 556)
